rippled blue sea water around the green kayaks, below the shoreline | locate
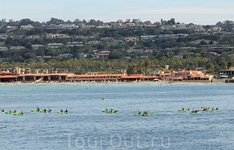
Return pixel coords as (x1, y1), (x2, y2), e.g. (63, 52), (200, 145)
(0, 84), (234, 150)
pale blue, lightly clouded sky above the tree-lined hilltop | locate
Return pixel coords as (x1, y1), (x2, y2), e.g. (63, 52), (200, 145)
(0, 0), (234, 25)
